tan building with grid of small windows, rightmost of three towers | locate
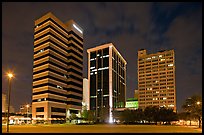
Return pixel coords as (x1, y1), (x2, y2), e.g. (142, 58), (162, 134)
(138, 49), (176, 111)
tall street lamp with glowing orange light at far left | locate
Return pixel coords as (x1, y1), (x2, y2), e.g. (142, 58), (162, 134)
(6, 73), (13, 132)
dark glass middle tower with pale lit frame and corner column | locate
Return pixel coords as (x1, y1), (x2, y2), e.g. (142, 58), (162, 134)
(87, 43), (127, 122)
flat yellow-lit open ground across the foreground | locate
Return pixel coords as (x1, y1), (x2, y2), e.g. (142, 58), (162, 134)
(2, 124), (202, 133)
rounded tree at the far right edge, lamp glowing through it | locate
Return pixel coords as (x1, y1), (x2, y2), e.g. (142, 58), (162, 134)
(182, 95), (202, 128)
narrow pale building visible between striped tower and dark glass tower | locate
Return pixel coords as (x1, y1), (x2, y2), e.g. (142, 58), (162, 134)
(82, 78), (90, 111)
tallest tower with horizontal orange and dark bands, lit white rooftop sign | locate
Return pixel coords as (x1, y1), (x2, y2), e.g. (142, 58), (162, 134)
(32, 12), (83, 123)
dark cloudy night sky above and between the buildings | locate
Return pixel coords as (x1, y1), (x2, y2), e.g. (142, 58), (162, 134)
(2, 2), (202, 111)
